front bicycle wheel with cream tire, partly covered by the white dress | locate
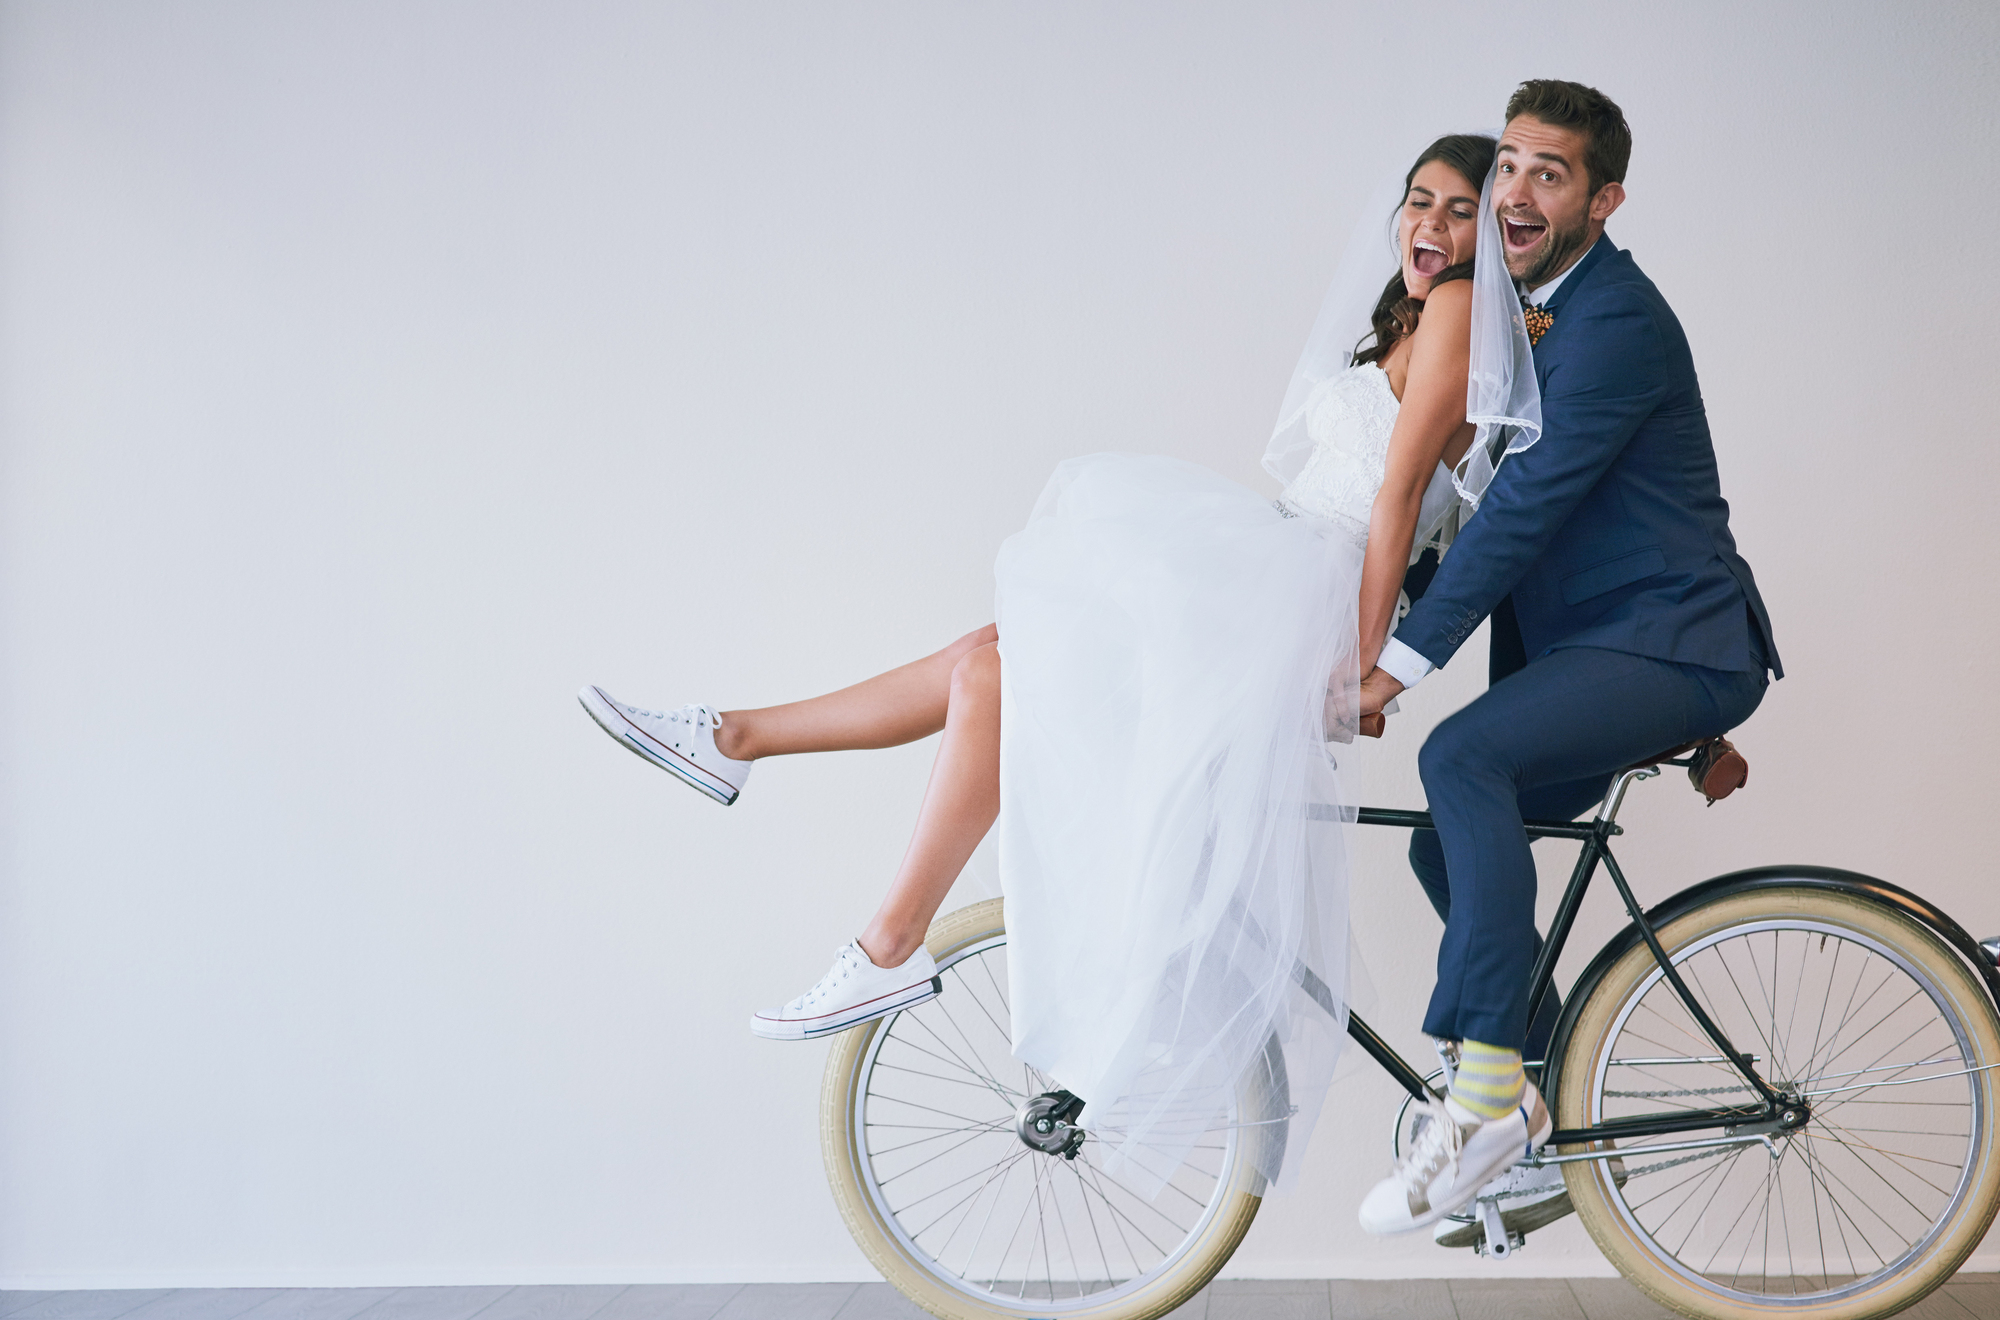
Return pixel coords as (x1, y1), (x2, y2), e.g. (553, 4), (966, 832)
(820, 898), (1286, 1320)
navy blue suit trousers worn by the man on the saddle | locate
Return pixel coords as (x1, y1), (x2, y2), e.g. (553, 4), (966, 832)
(1410, 648), (1766, 1058)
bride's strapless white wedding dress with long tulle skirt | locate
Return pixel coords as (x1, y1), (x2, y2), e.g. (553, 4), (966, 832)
(996, 366), (1458, 1194)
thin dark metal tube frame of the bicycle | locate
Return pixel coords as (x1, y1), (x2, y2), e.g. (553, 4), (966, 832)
(1348, 806), (1796, 1146)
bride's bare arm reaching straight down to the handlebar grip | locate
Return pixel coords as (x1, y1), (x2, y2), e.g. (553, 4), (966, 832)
(1360, 280), (1472, 674)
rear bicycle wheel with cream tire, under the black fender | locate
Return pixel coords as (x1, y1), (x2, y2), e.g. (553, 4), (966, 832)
(1558, 886), (2000, 1320)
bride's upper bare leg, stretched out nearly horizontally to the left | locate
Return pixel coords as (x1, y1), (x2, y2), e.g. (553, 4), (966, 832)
(716, 624), (1000, 756)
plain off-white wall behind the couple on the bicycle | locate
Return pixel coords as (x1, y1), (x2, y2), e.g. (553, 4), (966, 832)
(0, 0), (2000, 1286)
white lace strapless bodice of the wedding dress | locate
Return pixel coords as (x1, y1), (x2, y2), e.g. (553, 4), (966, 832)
(1278, 362), (1458, 564)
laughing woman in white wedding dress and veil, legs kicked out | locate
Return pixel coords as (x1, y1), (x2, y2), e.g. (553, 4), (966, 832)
(580, 134), (1540, 1174)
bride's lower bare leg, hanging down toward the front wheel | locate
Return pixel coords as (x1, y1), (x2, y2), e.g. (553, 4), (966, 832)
(852, 632), (1000, 968)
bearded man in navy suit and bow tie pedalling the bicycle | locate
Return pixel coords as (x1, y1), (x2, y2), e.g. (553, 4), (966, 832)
(1362, 80), (1784, 1232)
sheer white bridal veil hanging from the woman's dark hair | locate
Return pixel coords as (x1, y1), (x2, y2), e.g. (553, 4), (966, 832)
(1264, 134), (1542, 508)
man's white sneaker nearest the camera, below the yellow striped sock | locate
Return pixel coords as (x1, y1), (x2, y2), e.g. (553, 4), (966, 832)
(1360, 1082), (1556, 1232)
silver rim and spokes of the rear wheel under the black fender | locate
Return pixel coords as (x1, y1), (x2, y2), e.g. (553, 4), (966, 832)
(1572, 916), (2000, 1306)
